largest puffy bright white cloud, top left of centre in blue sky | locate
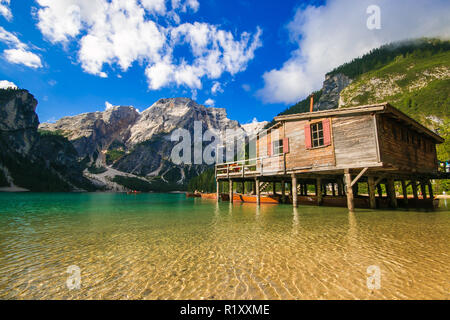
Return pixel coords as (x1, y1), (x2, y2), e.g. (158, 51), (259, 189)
(37, 0), (261, 90)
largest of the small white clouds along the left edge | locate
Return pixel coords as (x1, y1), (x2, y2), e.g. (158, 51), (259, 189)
(0, 27), (42, 69)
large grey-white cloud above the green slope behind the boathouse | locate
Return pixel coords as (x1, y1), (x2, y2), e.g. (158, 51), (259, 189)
(258, 0), (450, 103)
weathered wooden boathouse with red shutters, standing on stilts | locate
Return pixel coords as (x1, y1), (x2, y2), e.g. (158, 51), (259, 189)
(216, 103), (449, 211)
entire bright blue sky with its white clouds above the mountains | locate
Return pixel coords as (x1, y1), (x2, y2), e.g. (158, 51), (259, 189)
(0, 0), (450, 123)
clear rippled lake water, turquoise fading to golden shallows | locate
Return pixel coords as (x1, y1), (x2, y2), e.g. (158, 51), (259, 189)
(0, 193), (450, 299)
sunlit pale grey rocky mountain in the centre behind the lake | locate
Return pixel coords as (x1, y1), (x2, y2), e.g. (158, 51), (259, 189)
(39, 98), (255, 191)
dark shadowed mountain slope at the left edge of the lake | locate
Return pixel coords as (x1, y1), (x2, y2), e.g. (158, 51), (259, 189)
(0, 89), (96, 191)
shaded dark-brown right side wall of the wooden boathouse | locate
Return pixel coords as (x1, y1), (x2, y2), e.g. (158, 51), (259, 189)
(378, 115), (437, 173)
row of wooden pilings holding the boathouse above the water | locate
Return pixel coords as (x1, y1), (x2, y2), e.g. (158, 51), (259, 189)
(220, 169), (433, 211)
